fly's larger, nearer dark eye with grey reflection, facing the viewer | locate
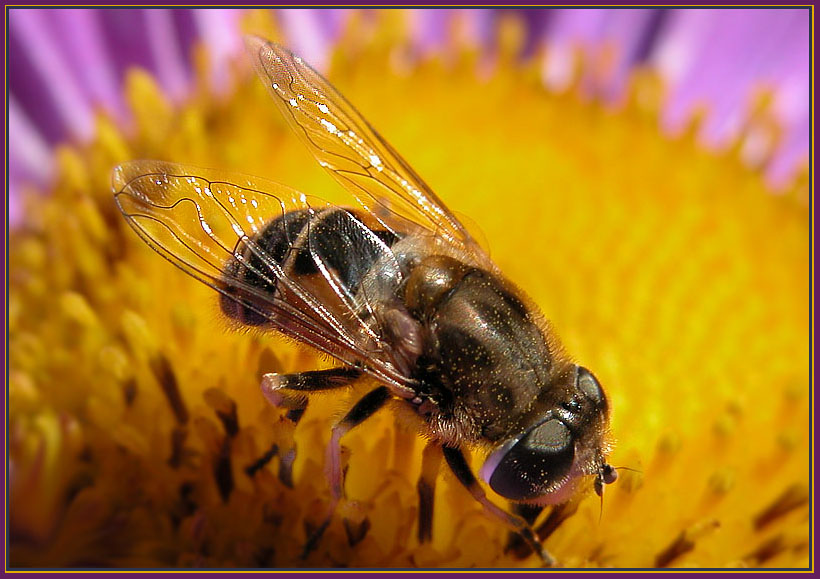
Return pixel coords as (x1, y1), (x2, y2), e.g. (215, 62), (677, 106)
(482, 419), (575, 501)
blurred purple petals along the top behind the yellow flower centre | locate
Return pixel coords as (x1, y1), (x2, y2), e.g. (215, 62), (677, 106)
(7, 8), (810, 229)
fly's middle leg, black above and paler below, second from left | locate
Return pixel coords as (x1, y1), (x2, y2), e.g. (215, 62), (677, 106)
(302, 386), (391, 559)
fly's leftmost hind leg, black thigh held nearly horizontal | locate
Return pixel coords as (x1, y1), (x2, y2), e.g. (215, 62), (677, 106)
(261, 366), (362, 488)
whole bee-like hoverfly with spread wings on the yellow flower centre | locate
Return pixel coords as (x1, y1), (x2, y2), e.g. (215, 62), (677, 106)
(113, 37), (617, 565)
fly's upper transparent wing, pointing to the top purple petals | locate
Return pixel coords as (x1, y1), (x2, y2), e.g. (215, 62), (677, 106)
(245, 36), (492, 267)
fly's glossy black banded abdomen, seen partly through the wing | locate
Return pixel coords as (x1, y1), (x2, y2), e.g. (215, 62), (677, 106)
(220, 207), (398, 326)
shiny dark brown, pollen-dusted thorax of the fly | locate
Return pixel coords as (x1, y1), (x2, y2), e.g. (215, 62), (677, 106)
(405, 256), (553, 441)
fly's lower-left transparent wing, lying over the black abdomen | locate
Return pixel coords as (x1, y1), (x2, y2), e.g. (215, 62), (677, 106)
(113, 161), (416, 389)
